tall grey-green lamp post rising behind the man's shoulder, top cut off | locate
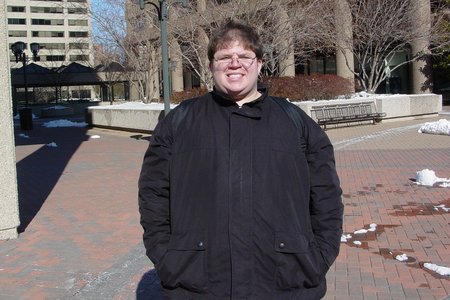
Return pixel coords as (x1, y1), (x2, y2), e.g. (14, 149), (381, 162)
(139, 0), (186, 116)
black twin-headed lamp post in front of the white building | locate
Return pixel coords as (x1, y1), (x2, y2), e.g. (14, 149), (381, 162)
(11, 41), (40, 130)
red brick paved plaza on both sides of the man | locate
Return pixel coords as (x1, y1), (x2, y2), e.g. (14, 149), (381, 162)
(0, 110), (450, 300)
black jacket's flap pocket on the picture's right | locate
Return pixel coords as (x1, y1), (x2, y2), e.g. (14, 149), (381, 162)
(274, 232), (328, 289)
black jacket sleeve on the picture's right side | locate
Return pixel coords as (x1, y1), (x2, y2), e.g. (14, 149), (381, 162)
(306, 120), (343, 267)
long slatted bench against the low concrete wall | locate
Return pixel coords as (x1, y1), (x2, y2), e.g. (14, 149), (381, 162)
(311, 102), (386, 130)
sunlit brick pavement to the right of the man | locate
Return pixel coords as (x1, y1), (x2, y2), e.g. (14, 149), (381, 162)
(325, 115), (450, 300)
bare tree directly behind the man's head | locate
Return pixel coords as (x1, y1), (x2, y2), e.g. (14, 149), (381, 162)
(169, 0), (333, 89)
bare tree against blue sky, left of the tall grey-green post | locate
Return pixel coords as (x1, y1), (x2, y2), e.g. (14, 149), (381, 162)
(90, 0), (159, 102)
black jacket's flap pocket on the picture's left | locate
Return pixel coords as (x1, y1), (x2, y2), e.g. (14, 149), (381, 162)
(155, 233), (207, 292)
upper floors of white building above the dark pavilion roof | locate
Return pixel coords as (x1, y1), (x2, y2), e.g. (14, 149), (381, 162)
(6, 0), (94, 68)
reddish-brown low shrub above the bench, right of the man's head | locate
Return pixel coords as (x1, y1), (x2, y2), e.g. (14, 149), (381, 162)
(262, 74), (352, 101)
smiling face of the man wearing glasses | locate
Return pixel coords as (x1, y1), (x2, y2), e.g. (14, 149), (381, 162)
(209, 41), (262, 103)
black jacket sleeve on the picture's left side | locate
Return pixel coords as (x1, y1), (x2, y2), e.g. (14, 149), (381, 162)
(138, 114), (173, 265)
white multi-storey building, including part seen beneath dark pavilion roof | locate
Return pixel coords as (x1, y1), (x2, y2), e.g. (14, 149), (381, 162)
(6, 0), (94, 103)
